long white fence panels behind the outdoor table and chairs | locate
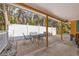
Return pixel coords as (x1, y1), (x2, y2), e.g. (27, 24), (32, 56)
(8, 24), (56, 37)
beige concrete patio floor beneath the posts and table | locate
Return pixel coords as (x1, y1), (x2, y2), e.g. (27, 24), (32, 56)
(16, 35), (79, 56)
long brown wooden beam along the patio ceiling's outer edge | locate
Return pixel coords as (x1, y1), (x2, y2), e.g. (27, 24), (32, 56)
(12, 3), (67, 22)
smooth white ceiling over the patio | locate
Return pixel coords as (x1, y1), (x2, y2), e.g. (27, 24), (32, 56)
(28, 3), (79, 20)
